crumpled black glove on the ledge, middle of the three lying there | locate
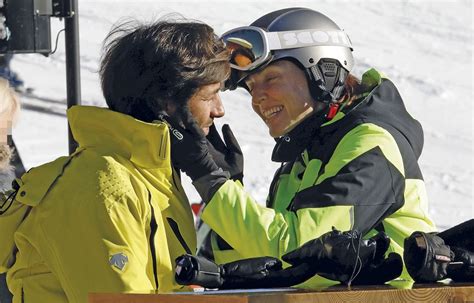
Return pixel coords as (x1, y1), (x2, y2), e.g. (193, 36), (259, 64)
(282, 228), (403, 284)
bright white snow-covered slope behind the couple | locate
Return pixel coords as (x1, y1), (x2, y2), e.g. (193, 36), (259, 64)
(12, 0), (474, 229)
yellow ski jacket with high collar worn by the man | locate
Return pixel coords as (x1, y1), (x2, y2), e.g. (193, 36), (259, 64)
(0, 106), (196, 302)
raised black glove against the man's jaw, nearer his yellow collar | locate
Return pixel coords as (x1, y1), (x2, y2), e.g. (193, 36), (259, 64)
(159, 113), (219, 181)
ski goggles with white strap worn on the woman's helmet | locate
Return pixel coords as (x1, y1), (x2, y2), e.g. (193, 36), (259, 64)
(221, 26), (352, 72)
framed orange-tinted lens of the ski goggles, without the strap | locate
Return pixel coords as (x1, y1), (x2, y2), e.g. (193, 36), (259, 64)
(222, 28), (269, 71)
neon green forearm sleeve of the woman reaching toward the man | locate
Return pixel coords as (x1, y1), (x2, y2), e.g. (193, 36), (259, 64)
(202, 181), (352, 258)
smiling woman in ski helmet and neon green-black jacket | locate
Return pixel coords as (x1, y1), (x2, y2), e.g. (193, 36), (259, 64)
(170, 8), (435, 283)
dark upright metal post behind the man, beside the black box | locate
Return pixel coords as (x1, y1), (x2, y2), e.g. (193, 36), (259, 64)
(64, 0), (81, 154)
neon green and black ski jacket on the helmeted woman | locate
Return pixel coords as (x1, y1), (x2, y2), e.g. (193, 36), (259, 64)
(202, 69), (436, 287)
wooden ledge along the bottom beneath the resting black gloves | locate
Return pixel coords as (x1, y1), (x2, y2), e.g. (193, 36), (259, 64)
(89, 283), (474, 303)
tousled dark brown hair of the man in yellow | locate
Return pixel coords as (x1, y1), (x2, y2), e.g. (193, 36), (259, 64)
(100, 18), (230, 122)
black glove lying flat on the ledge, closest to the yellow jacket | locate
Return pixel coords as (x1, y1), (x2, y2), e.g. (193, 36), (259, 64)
(175, 255), (314, 289)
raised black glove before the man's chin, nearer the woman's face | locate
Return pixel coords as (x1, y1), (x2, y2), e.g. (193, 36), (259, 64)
(207, 124), (244, 183)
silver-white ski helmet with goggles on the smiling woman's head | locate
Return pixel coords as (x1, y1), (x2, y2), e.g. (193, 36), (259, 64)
(222, 8), (354, 102)
